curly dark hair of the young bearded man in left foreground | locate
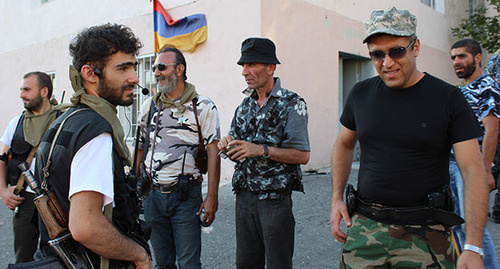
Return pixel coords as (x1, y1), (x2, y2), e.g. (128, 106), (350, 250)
(69, 23), (143, 72)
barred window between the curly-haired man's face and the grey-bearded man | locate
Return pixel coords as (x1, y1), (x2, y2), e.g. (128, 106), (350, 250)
(118, 54), (156, 142)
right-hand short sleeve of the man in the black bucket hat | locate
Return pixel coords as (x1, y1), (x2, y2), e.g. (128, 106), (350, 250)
(281, 98), (311, 151)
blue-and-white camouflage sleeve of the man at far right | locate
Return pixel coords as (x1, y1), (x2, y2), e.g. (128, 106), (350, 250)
(478, 79), (500, 121)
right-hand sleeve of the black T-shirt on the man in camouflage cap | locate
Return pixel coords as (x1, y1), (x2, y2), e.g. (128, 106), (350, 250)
(448, 88), (483, 144)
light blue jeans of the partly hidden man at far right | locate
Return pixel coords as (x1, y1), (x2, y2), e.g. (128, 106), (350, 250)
(449, 159), (500, 269)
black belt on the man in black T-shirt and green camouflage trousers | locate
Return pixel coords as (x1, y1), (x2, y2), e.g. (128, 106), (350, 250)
(355, 197), (464, 227)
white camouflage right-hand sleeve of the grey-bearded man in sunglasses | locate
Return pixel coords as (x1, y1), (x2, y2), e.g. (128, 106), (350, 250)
(199, 99), (220, 145)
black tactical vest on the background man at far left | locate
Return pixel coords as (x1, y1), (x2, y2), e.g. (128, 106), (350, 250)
(7, 112), (33, 186)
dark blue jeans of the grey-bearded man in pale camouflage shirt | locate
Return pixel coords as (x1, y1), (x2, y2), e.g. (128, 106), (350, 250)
(144, 186), (202, 269)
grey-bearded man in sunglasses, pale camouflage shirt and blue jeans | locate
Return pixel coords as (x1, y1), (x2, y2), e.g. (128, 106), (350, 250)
(137, 47), (220, 268)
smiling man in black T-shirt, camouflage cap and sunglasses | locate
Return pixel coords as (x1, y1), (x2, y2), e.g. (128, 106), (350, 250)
(330, 7), (488, 268)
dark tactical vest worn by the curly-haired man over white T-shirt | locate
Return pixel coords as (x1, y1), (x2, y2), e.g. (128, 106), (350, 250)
(36, 105), (149, 268)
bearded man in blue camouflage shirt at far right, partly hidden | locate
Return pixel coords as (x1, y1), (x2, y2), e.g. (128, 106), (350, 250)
(449, 39), (500, 268)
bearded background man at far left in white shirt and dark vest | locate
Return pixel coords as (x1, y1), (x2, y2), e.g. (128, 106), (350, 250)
(0, 72), (60, 263)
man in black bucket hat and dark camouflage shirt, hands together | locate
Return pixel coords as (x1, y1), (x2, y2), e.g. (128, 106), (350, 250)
(218, 38), (310, 268)
